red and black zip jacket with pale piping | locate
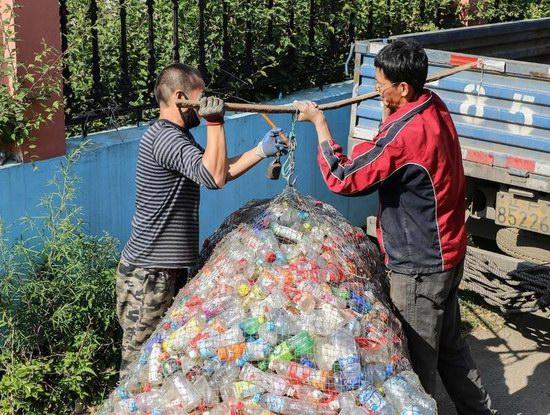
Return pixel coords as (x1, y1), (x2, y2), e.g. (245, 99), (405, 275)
(318, 90), (466, 274)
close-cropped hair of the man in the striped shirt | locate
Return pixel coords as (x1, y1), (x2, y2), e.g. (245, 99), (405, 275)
(155, 63), (204, 104)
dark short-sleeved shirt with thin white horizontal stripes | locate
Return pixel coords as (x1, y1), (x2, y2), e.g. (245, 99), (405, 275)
(122, 120), (218, 268)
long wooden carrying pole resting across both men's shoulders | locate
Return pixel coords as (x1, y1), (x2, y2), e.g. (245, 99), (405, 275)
(176, 62), (478, 114)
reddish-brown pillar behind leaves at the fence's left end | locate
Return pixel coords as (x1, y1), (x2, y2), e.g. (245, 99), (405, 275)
(0, 0), (65, 161)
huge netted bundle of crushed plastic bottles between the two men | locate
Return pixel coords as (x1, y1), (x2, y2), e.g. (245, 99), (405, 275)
(100, 188), (437, 415)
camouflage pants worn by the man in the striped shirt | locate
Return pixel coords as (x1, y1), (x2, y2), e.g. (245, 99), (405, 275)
(116, 260), (188, 379)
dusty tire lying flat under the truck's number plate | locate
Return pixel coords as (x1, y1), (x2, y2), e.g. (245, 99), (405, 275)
(496, 228), (550, 264)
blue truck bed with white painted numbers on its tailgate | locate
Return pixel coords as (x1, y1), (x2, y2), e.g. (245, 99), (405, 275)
(350, 18), (550, 193)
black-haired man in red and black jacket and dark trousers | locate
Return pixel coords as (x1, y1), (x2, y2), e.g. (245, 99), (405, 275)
(294, 40), (494, 415)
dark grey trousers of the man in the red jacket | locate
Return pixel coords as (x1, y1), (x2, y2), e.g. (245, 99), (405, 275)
(389, 264), (496, 415)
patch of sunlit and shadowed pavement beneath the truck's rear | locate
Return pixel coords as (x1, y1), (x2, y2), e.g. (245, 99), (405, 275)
(436, 311), (550, 415)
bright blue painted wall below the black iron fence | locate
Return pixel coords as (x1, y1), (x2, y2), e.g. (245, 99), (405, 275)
(0, 82), (375, 249)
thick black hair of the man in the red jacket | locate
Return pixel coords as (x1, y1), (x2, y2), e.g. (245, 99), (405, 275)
(374, 40), (428, 92)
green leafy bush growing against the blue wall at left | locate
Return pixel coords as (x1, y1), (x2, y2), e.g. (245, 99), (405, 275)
(0, 148), (121, 415)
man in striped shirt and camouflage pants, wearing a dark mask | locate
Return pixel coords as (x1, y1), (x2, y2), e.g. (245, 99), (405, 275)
(116, 64), (286, 378)
